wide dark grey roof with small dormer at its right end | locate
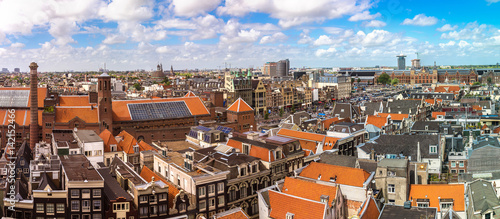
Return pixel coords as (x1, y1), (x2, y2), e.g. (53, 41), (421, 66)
(358, 135), (440, 160)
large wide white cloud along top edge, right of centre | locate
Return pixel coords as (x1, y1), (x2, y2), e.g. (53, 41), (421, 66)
(217, 0), (372, 28)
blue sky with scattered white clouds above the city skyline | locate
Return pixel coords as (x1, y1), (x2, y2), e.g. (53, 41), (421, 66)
(0, 0), (500, 72)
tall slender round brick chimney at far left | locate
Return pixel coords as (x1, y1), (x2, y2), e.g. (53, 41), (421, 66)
(30, 62), (39, 149)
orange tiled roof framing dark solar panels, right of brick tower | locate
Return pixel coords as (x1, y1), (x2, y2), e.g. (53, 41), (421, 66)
(113, 97), (210, 121)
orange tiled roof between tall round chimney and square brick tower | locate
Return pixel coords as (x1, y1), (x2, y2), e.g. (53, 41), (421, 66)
(55, 107), (99, 123)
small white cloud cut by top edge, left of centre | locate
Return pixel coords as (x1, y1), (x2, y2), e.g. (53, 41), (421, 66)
(170, 0), (221, 17)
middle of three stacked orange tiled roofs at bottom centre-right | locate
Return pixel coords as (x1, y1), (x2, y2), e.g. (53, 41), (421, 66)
(281, 177), (337, 207)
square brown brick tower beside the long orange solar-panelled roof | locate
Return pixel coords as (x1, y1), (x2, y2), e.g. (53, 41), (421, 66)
(97, 73), (113, 133)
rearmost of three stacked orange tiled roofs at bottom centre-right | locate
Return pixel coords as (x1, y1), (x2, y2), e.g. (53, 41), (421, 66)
(300, 162), (370, 187)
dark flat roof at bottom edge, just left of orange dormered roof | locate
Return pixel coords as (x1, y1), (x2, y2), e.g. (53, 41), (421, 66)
(379, 204), (437, 219)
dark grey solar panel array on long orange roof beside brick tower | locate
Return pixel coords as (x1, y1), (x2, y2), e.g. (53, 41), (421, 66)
(127, 101), (191, 120)
